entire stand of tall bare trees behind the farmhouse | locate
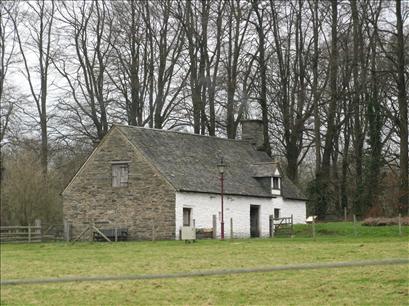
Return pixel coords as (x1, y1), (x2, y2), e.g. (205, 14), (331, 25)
(0, 0), (409, 217)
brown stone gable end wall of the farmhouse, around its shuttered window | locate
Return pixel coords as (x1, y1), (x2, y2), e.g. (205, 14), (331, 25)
(63, 128), (175, 240)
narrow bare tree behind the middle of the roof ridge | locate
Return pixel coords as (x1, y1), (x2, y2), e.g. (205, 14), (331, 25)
(174, 0), (226, 135)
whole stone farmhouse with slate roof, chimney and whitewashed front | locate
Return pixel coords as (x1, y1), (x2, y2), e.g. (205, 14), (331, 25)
(62, 120), (306, 240)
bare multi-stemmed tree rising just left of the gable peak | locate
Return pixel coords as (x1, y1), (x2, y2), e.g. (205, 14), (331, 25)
(55, 1), (112, 142)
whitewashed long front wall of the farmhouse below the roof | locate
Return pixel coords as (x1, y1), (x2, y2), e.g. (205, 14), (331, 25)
(175, 192), (305, 239)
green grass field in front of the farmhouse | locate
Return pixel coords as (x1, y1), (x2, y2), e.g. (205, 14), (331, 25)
(1, 223), (409, 305)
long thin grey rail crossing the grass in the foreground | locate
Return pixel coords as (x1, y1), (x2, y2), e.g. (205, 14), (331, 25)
(0, 258), (409, 286)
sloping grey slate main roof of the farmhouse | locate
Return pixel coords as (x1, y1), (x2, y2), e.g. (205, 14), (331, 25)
(116, 125), (305, 199)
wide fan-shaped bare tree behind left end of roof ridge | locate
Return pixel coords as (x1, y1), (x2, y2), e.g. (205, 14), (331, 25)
(108, 0), (189, 128)
